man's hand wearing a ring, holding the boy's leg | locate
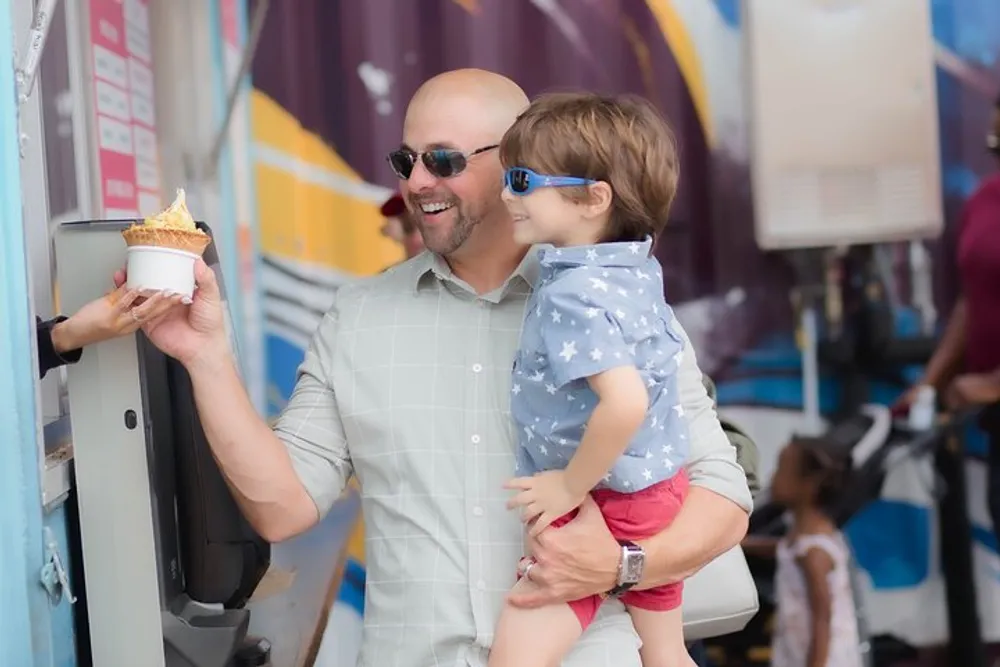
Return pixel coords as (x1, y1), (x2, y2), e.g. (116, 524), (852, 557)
(509, 495), (622, 608)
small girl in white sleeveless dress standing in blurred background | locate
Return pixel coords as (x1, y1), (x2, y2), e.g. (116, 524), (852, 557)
(745, 437), (861, 667)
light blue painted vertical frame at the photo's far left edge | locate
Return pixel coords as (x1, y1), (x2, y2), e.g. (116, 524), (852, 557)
(0, 0), (52, 667)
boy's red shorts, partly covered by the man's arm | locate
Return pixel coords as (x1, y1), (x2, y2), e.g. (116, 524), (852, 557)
(524, 470), (688, 630)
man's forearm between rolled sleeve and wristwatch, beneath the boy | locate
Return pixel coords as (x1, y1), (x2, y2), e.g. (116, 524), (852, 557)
(636, 486), (749, 589)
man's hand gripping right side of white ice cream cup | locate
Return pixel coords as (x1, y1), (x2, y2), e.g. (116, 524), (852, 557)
(115, 259), (229, 369)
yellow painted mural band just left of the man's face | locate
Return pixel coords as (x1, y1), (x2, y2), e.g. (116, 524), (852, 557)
(251, 90), (403, 275)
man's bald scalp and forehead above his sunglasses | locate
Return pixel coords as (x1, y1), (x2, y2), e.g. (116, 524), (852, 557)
(403, 68), (528, 142)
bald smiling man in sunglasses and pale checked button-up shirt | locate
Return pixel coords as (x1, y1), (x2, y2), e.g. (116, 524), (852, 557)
(137, 70), (750, 667)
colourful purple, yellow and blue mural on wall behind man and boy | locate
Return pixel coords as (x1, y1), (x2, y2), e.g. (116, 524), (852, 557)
(244, 0), (1000, 667)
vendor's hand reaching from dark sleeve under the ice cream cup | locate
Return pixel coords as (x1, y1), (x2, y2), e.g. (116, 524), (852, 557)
(52, 285), (181, 354)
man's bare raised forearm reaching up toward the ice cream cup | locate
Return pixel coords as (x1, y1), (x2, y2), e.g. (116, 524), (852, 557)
(188, 351), (319, 542)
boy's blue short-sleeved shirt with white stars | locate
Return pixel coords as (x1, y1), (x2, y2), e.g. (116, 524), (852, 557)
(511, 240), (688, 493)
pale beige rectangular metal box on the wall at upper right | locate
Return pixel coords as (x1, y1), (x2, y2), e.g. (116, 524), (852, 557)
(742, 0), (943, 250)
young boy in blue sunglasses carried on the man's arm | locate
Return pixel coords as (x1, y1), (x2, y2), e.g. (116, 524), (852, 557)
(490, 94), (693, 667)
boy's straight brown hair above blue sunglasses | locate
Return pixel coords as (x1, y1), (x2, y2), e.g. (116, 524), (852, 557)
(500, 93), (679, 241)
